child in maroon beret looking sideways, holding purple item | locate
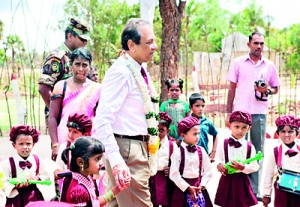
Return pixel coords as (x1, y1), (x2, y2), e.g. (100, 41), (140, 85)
(170, 117), (213, 207)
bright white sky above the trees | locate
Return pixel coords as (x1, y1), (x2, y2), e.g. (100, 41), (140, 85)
(0, 0), (300, 53)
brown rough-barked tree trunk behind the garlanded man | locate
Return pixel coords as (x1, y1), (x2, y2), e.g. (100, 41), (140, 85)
(159, 0), (186, 102)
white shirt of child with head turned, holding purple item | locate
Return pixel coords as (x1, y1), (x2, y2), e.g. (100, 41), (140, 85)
(170, 142), (212, 192)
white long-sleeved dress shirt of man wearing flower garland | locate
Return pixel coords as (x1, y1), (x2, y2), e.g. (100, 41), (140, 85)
(93, 54), (148, 167)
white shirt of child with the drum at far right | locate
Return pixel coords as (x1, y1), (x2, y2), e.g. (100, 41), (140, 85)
(263, 140), (300, 195)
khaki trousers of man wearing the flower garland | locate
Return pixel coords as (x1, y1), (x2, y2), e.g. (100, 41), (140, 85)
(105, 138), (152, 207)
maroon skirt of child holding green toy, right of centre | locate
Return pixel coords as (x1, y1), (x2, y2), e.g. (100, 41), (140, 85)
(215, 173), (258, 207)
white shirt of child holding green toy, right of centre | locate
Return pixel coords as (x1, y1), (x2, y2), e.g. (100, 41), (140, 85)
(216, 137), (259, 174)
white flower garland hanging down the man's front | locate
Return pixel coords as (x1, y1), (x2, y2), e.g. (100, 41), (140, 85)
(126, 58), (160, 176)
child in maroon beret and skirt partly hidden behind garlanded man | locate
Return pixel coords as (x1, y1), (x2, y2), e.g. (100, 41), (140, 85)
(149, 112), (177, 207)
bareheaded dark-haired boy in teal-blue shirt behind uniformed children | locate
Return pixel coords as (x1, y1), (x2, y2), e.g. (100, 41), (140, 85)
(189, 93), (218, 162)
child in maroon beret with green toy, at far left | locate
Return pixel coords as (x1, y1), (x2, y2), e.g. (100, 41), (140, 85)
(2, 125), (49, 207)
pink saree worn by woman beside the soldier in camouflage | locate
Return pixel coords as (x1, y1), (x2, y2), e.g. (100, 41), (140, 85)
(57, 82), (101, 144)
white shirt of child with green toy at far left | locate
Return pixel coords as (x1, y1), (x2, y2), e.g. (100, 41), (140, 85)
(1, 154), (50, 198)
